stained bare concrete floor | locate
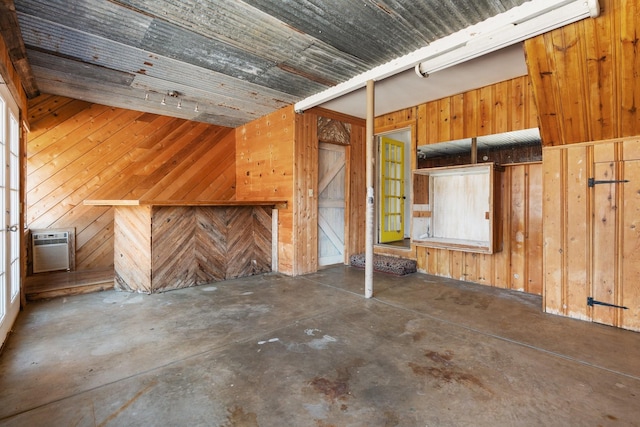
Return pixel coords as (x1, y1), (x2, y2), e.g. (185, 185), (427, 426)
(0, 266), (640, 427)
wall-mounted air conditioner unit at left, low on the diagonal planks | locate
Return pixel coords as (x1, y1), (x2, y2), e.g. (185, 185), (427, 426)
(31, 231), (69, 273)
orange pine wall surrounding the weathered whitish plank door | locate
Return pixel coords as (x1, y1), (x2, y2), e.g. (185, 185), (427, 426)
(236, 106), (365, 275)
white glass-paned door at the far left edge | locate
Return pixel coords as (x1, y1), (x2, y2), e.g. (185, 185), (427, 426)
(0, 84), (20, 343)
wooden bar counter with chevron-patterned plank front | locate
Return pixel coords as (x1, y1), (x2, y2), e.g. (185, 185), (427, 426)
(84, 200), (286, 293)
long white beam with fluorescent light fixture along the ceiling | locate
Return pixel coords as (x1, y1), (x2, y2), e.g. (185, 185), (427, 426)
(294, 0), (600, 112)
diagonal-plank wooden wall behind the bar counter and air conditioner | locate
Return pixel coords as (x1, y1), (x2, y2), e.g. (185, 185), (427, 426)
(26, 95), (236, 270)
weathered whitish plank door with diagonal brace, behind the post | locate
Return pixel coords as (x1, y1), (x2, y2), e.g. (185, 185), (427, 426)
(318, 142), (345, 266)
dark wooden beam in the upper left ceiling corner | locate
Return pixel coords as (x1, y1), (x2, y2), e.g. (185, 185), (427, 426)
(0, 0), (40, 99)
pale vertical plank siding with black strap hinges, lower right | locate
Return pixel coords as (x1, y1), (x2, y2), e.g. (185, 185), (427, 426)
(543, 137), (640, 331)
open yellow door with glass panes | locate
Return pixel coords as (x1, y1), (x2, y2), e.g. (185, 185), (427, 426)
(380, 137), (404, 243)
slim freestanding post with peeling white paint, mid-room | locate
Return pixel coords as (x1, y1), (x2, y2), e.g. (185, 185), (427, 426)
(364, 80), (375, 298)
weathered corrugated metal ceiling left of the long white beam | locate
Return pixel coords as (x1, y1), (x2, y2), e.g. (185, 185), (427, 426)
(15, 0), (526, 127)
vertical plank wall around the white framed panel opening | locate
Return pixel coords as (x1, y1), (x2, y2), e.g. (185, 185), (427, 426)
(376, 76), (542, 294)
